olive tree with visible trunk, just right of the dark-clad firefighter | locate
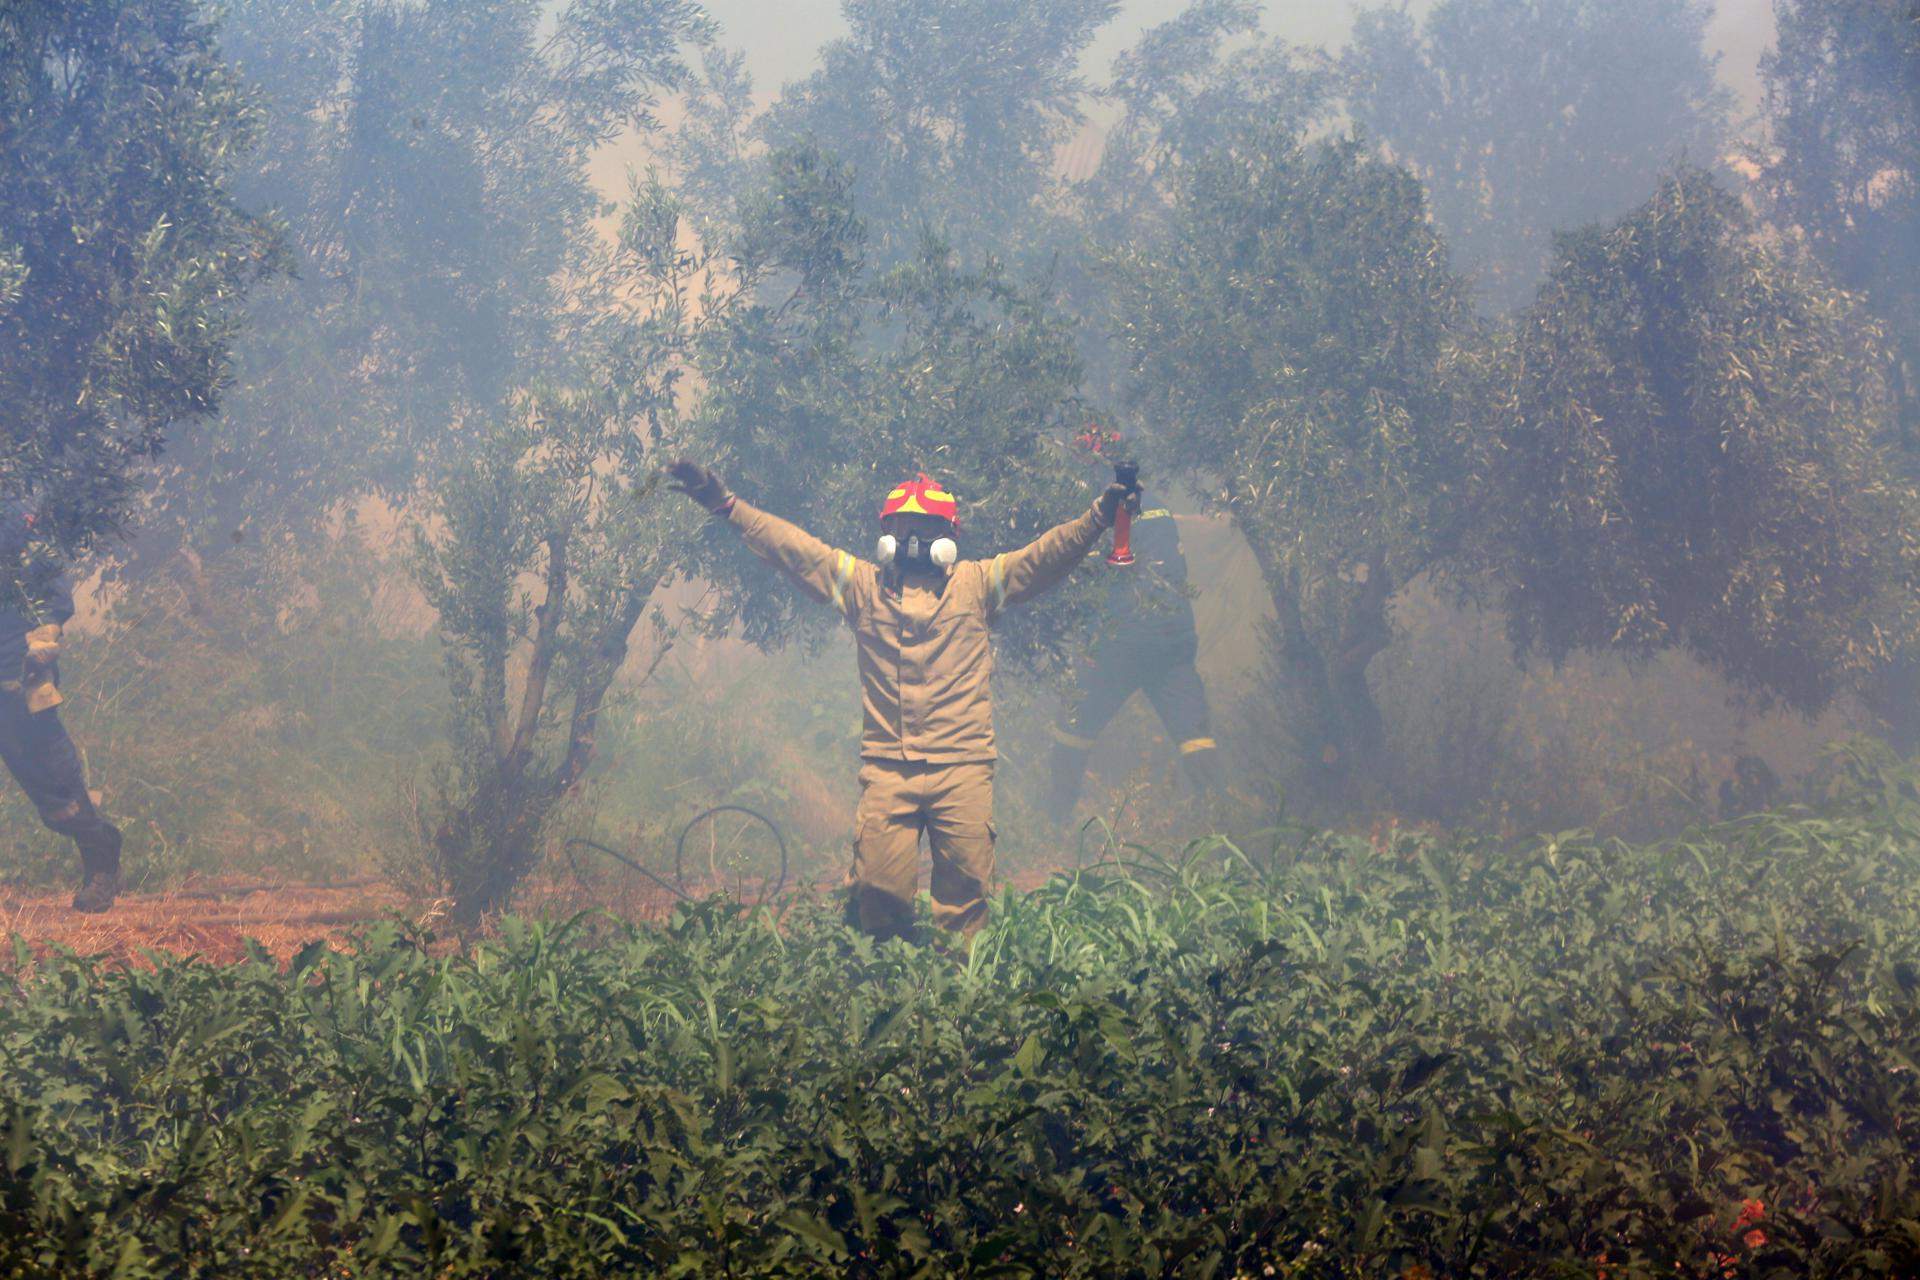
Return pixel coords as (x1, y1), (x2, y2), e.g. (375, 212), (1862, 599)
(1116, 129), (1476, 793)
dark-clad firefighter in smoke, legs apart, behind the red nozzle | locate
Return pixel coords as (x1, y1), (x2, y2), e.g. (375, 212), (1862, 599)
(1048, 493), (1219, 825)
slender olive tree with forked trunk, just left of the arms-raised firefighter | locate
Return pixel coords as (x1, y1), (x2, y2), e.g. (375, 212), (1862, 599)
(415, 184), (724, 921)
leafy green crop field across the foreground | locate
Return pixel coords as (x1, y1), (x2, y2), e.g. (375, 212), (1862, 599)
(0, 744), (1920, 1280)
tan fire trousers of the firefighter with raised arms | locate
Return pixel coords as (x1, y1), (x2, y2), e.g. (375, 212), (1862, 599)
(847, 760), (995, 938)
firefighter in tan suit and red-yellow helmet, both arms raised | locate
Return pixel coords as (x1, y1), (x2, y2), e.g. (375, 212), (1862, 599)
(668, 461), (1127, 938)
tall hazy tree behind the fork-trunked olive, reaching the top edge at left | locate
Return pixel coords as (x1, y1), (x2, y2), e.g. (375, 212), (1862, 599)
(131, 0), (710, 579)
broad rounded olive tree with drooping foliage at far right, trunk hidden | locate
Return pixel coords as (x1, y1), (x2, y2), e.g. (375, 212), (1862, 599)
(1480, 169), (1920, 712)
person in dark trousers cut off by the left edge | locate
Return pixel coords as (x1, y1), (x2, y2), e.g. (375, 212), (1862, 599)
(0, 501), (121, 912)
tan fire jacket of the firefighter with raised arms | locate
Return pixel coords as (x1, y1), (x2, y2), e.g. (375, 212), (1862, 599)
(726, 499), (1106, 764)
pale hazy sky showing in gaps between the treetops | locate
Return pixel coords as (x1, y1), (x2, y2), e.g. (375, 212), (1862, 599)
(707, 0), (1774, 107)
